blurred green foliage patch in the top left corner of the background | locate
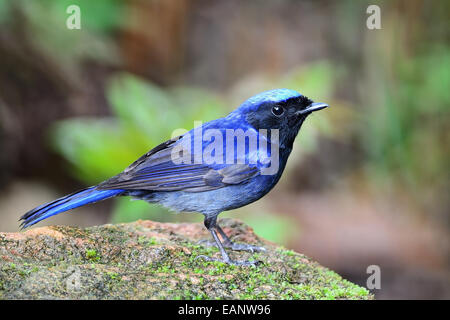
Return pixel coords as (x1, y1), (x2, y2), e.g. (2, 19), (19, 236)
(0, 0), (125, 66)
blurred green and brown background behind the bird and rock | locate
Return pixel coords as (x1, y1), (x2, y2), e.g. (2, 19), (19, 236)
(0, 0), (450, 299)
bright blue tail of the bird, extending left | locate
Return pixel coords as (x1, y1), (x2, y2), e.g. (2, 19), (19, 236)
(20, 187), (124, 229)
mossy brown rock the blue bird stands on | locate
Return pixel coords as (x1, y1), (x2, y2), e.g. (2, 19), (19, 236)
(0, 219), (373, 299)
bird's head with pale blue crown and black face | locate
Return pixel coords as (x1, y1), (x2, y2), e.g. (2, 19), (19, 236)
(236, 89), (328, 147)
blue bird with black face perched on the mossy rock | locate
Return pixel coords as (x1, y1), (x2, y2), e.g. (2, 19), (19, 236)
(20, 89), (328, 265)
